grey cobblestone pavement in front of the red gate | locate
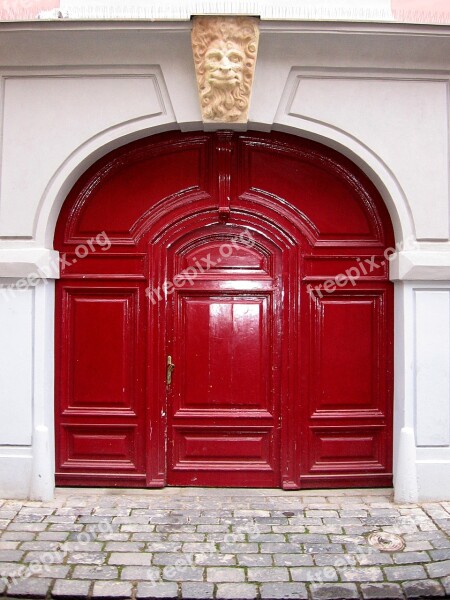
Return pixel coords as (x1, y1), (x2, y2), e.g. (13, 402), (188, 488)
(0, 488), (450, 600)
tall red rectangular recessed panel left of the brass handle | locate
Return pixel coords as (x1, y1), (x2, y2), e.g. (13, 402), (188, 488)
(64, 287), (137, 414)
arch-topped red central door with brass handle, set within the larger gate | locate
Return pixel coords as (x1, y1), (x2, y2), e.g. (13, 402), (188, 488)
(161, 225), (282, 487)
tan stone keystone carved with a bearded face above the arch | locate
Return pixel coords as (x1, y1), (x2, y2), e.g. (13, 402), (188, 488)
(192, 17), (259, 123)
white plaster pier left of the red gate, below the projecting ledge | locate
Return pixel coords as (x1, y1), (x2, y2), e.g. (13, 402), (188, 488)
(0, 279), (49, 498)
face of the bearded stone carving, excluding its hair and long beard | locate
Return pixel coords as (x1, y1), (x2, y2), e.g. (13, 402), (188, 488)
(205, 40), (245, 89)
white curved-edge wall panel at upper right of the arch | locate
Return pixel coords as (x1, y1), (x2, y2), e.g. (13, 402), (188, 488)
(278, 76), (449, 239)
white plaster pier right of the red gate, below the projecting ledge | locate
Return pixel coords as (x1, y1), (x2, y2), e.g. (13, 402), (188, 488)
(394, 281), (450, 502)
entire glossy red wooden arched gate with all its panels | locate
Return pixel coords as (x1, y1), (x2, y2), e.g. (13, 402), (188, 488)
(55, 131), (394, 489)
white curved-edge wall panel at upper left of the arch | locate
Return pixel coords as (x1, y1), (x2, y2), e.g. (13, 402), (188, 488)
(0, 71), (171, 238)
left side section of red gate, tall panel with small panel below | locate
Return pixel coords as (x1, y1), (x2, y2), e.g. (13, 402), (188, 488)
(56, 280), (145, 485)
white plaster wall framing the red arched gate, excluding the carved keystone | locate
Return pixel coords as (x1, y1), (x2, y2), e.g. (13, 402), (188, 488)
(0, 23), (450, 500)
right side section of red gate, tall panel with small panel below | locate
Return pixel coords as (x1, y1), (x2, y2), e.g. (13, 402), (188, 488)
(302, 282), (391, 486)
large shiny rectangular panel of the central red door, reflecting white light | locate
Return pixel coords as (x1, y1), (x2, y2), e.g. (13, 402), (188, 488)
(178, 295), (271, 411)
